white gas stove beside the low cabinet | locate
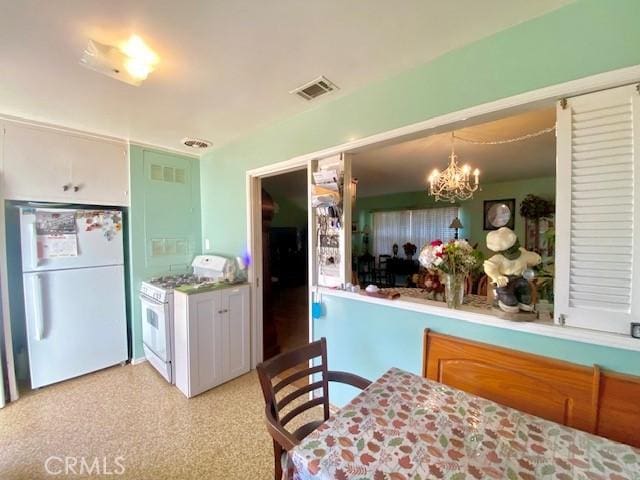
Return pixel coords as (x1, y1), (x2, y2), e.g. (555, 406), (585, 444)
(140, 255), (239, 383)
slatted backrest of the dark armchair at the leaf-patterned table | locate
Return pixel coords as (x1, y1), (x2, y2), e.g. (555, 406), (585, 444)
(256, 338), (329, 437)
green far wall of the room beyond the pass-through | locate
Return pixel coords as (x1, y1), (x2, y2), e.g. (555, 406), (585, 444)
(354, 177), (556, 254)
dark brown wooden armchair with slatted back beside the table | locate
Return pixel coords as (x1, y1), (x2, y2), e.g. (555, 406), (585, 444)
(256, 338), (371, 480)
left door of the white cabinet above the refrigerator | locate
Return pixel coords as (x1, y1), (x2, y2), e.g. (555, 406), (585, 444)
(2, 123), (71, 202)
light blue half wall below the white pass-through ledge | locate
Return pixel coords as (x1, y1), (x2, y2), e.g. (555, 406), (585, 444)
(313, 295), (640, 405)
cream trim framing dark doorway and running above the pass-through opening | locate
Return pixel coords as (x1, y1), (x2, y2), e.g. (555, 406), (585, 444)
(246, 65), (640, 368)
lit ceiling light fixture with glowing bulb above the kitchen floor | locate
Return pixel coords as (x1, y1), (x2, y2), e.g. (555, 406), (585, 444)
(80, 35), (159, 87)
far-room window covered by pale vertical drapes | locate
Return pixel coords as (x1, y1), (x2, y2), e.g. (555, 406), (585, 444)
(372, 207), (458, 257)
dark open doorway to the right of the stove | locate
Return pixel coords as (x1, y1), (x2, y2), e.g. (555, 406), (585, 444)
(260, 168), (309, 360)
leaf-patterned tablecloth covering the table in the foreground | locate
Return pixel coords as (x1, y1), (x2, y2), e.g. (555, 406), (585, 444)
(285, 368), (640, 480)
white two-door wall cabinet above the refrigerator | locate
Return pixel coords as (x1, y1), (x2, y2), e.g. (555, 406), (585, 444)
(1, 121), (129, 205)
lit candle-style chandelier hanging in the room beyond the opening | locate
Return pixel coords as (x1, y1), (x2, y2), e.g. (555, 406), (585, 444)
(429, 132), (480, 203)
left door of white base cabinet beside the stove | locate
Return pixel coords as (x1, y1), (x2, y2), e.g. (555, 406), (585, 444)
(189, 292), (224, 396)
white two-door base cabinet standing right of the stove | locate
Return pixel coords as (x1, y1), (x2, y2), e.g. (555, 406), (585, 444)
(174, 285), (250, 397)
